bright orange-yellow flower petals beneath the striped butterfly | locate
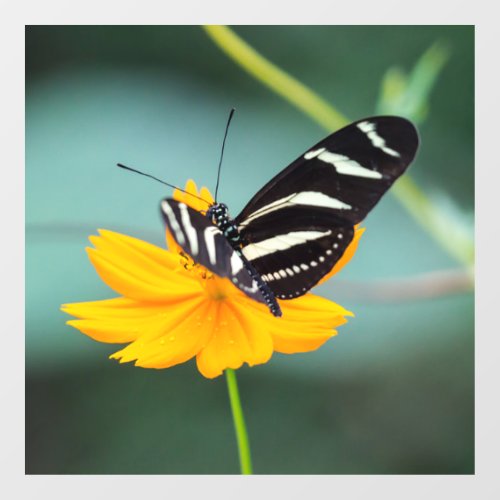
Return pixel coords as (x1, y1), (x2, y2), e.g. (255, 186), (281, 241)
(62, 181), (363, 378)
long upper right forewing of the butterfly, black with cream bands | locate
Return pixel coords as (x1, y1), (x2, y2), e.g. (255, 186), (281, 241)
(235, 116), (418, 228)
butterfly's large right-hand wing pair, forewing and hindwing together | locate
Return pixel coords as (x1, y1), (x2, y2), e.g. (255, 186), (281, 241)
(235, 116), (419, 298)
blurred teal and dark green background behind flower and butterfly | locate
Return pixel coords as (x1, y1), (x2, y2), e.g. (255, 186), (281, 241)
(26, 26), (474, 474)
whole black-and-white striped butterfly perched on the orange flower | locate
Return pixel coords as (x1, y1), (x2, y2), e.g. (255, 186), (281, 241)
(160, 116), (419, 316)
